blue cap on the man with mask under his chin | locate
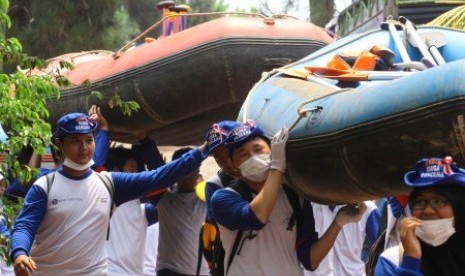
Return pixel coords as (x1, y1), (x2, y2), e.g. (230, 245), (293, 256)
(52, 113), (98, 143)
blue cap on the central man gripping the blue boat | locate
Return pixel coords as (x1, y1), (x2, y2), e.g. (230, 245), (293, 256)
(224, 120), (270, 153)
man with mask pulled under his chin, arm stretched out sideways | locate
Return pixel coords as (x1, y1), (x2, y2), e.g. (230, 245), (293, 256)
(11, 113), (205, 275)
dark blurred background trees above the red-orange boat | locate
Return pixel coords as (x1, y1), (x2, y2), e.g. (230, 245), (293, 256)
(8, 0), (232, 58)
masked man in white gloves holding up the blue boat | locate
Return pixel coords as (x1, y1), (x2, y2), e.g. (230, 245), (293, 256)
(212, 121), (366, 275)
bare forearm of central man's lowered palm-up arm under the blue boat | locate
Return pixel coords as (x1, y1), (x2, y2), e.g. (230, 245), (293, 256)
(310, 220), (342, 270)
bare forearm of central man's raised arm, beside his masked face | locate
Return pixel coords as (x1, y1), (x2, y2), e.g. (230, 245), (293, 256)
(250, 170), (283, 223)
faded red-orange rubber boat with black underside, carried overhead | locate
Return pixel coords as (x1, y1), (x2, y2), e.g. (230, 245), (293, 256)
(42, 16), (334, 145)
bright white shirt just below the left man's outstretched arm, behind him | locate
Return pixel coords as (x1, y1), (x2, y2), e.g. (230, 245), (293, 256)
(105, 199), (148, 276)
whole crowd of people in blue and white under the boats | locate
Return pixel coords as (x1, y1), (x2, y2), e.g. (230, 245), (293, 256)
(0, 106), (465, 276)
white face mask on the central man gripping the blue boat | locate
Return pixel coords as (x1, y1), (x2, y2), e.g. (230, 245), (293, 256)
(239, 154), (271, 182)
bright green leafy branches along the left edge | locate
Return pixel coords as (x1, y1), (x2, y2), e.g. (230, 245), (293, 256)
(0, 0), (60, 260)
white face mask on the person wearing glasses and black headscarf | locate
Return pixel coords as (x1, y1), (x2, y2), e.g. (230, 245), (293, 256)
(415, 217), (455, 247)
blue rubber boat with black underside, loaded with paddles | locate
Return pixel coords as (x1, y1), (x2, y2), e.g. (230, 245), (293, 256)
(238, 18), (465, 204)
